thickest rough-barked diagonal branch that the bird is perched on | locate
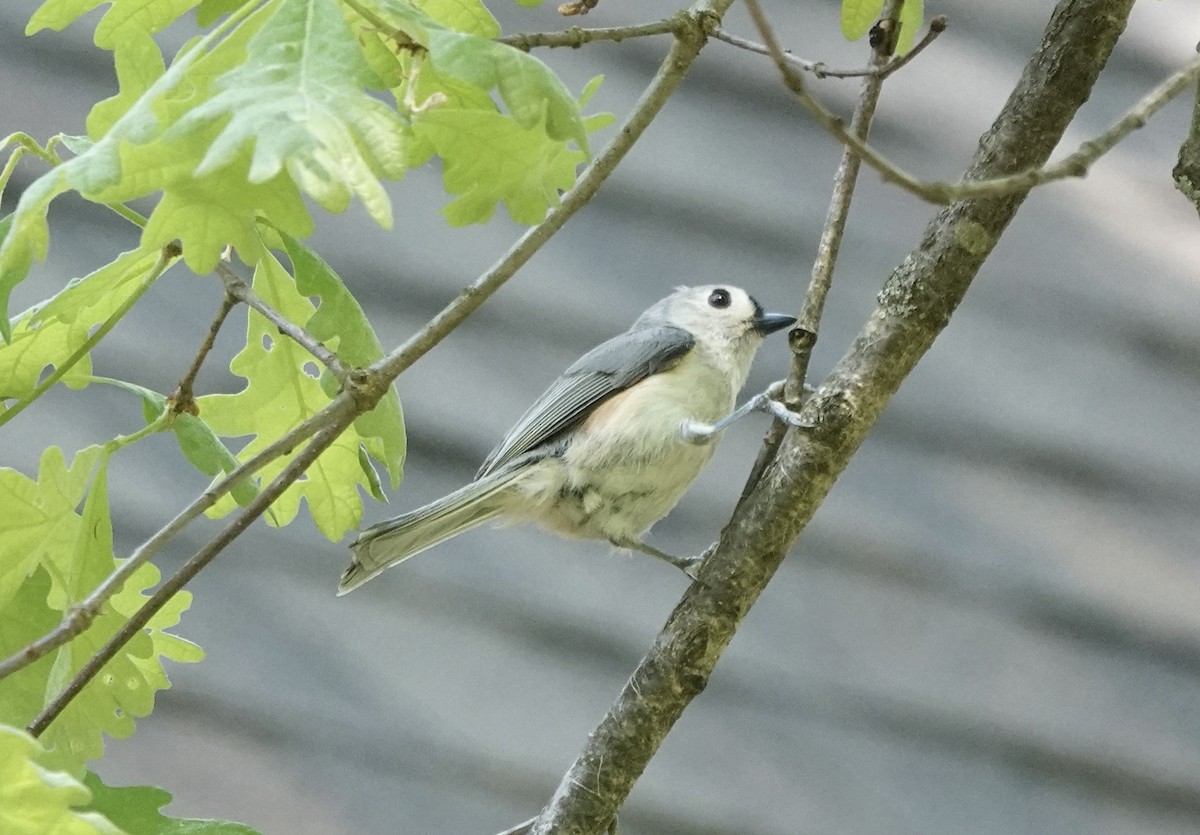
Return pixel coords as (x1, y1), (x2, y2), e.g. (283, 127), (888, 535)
(534, 0), (1133, 835)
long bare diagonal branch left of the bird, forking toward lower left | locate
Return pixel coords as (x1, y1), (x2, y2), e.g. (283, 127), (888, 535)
(23, 0), (731, 735)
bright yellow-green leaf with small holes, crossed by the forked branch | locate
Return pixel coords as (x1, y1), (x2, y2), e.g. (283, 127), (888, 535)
(198, 254), (381, 541)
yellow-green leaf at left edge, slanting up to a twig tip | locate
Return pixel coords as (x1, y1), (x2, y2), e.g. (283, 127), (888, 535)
(0, 250), (160, 400)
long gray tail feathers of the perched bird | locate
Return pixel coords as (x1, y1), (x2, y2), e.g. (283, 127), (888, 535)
(337, 474), (512, 596)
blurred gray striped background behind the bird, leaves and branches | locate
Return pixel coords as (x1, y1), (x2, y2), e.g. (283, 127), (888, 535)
(0, 0), (1200, 835)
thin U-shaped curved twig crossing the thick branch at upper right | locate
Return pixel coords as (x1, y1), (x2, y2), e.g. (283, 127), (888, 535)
(746, 0), (1200, 204)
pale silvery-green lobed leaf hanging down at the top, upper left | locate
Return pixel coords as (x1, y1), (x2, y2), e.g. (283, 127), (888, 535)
(168, 0), (407, 225)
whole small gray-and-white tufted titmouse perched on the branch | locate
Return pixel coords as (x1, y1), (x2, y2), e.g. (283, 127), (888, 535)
(337, 284), (800, 595)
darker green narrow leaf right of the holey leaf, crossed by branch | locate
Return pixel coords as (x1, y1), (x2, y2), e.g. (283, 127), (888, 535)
(281, 227), (407, 489)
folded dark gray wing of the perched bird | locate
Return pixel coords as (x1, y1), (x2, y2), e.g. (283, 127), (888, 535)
(475, 325), (695, 479)
